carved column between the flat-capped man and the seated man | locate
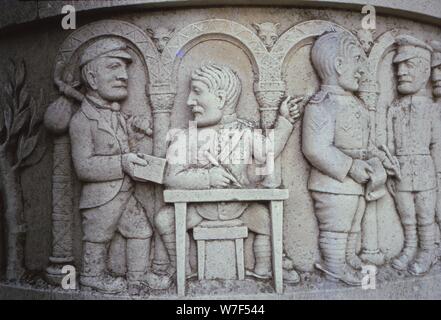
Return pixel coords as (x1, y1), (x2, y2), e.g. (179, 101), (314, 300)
(149, 86), (175, 272)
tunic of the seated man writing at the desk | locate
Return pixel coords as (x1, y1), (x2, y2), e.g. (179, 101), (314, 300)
(157, 114), (293, 235)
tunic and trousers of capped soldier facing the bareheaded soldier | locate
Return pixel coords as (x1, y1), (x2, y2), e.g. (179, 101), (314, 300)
(387, 95), (441, 225)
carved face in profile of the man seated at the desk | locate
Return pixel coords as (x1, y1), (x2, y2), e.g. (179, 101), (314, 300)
(187, 80), (225, 127)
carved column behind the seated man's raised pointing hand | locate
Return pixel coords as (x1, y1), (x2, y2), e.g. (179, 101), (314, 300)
(254, 82), (286, 188)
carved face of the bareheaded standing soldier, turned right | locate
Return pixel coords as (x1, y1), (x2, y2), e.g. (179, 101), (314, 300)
(335, 46), (364, 92)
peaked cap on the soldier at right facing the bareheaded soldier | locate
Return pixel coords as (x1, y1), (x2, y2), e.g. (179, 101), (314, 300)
(393, 35), (433, 63)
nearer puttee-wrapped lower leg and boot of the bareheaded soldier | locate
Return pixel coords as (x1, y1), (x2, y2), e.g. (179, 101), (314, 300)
(315, 231), (363, 286)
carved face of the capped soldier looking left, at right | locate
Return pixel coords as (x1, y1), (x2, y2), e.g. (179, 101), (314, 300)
(397, 58), (430, 94)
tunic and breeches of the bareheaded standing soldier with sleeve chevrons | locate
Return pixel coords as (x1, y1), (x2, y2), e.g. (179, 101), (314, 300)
(302, 85), (384, 232)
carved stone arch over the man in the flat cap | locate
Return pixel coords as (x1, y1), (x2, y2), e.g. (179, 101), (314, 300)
(56, 20), (162, 92)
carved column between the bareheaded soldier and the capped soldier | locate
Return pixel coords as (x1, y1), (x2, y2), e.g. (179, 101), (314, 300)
(359, 77), (384, 265)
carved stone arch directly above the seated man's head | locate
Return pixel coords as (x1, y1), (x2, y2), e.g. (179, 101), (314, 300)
(161, 19), (274, 90)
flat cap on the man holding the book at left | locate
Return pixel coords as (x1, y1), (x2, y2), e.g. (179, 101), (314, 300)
(80, 38), (132, 67)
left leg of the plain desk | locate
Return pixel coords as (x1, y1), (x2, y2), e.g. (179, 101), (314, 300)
(175, 202), (187, 297)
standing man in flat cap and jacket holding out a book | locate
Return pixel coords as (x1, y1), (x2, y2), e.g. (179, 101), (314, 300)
(70, 38), (169, 293)
